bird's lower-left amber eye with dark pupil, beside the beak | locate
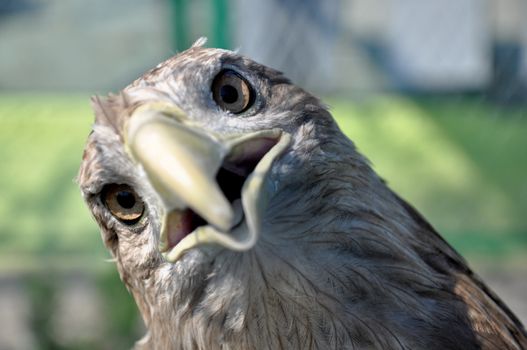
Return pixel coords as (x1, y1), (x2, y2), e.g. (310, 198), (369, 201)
(102, 184), (145, 225)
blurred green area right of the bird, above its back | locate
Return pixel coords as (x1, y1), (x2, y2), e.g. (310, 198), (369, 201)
(330, 97), (527, 256)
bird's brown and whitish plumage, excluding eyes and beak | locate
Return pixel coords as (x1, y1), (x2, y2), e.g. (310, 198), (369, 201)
(78, 45), (527, 350)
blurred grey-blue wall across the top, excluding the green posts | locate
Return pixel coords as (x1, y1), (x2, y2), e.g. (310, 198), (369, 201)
(0, 0), (527, 93)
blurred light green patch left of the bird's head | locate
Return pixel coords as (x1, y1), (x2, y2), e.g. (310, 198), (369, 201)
(0, 95), (107, 265)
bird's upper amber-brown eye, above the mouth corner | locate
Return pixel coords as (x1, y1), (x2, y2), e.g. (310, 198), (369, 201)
(212, 69), (254, 114)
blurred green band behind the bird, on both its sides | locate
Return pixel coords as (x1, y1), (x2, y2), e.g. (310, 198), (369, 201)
(0, 94), (527, 268)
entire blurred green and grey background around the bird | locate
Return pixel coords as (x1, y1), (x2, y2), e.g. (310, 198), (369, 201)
(0, 0), (527, 349)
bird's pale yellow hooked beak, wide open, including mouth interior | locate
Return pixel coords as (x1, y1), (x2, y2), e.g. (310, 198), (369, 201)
(125, 103), (291, 262)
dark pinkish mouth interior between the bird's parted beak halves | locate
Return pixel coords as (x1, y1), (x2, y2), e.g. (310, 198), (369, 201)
(161, 137), (278, 252)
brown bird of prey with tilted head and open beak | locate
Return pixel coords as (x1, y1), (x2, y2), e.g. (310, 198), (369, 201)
(78, 40), (527, 350)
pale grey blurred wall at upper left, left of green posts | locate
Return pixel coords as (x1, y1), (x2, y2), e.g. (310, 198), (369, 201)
(0, 0), (172, 92)
